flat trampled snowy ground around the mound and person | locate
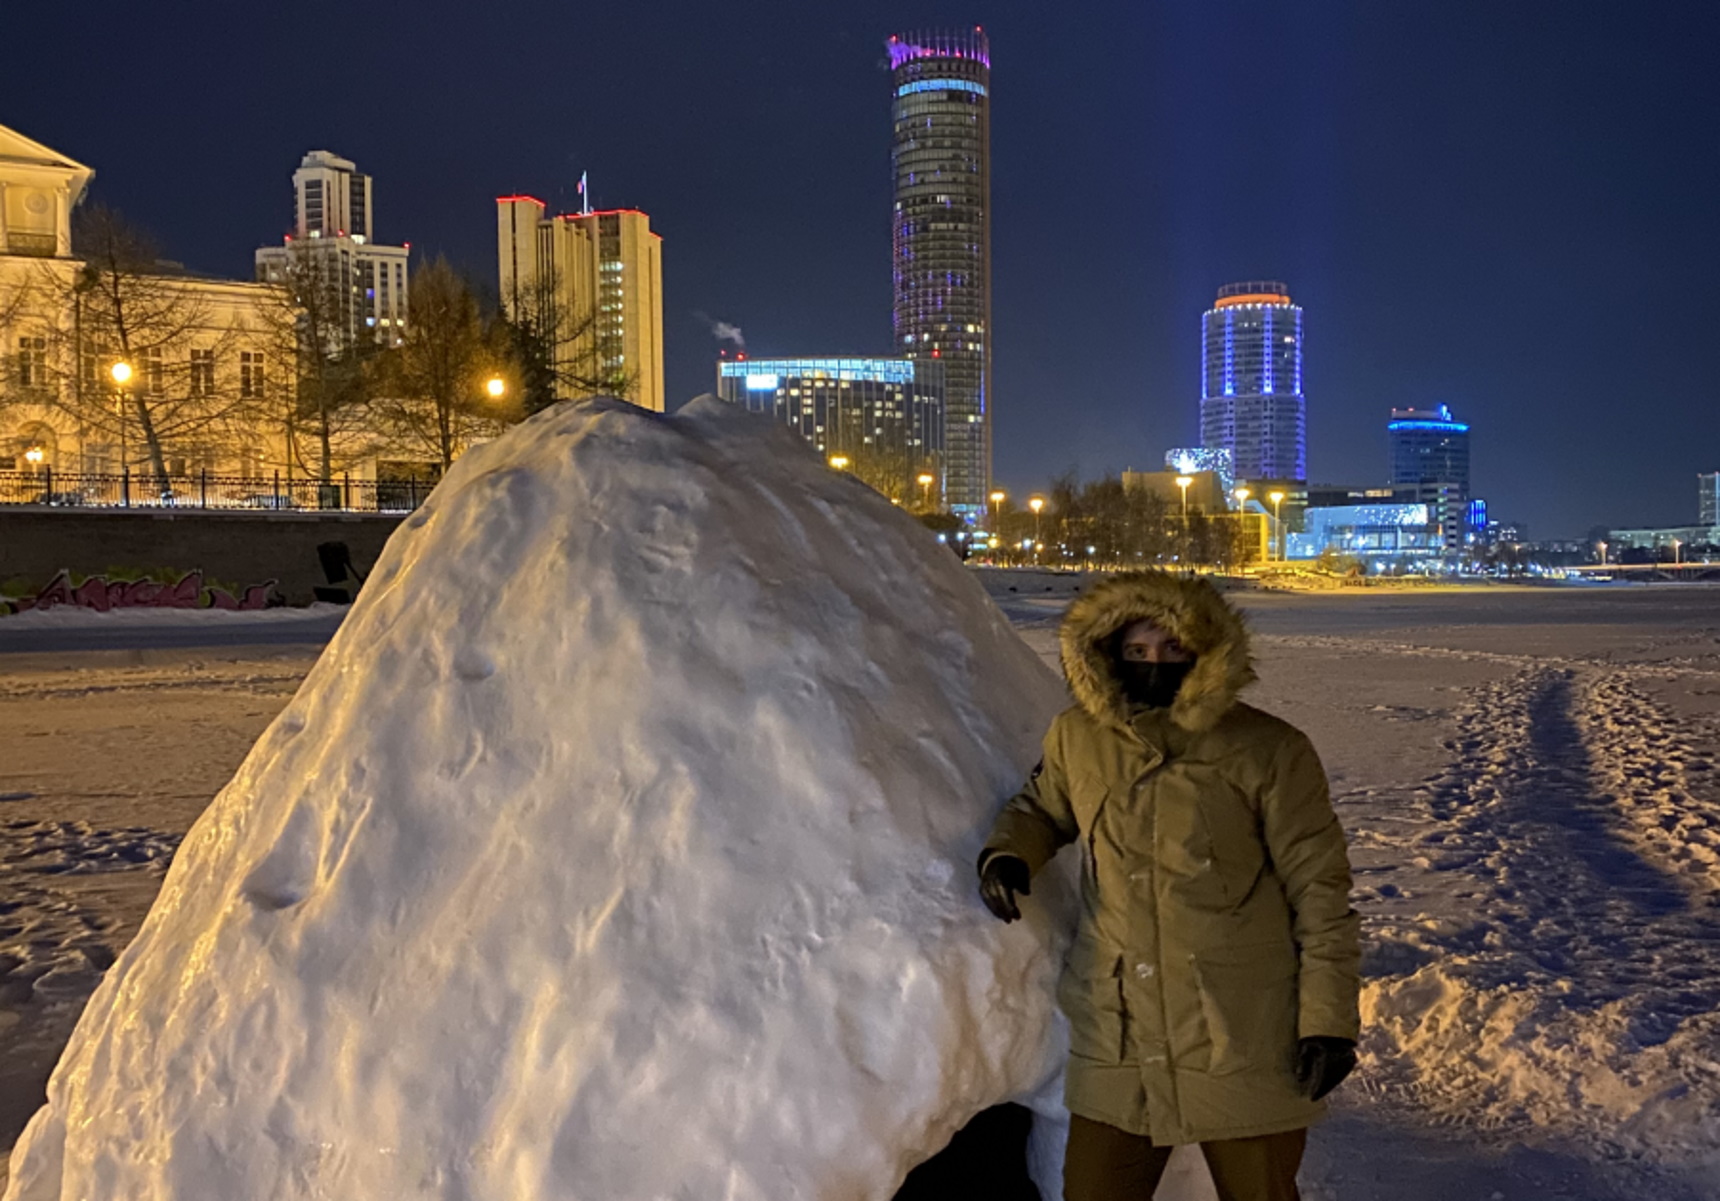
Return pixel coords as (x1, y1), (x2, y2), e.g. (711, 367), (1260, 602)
(0, 573), (1720, 1201)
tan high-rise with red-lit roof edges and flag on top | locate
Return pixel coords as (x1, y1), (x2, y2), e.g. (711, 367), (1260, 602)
(495, 196), (664, 413)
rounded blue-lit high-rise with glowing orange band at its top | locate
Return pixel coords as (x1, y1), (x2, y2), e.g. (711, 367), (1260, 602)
(1201, 280), (1307, 482)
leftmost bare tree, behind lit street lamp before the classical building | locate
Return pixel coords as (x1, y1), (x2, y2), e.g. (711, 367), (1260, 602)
(41, 205), (260, 490)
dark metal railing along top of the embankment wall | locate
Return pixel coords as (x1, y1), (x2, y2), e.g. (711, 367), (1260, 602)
(0, 468), (433, 513)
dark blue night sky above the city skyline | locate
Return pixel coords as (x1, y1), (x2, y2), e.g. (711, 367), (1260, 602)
(0, 0), (1720, 537)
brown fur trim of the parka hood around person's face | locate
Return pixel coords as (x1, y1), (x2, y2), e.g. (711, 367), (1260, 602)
(1058, 571), (1256, 733)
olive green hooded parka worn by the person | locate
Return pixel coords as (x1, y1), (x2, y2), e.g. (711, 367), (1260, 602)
(982, 571), (1361, 1146)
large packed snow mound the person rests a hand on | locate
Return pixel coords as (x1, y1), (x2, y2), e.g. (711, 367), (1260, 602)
(5, 401), (1068, 1201)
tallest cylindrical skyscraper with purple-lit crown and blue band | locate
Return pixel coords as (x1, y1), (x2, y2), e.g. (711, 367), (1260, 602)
(888, 26), (991, 518)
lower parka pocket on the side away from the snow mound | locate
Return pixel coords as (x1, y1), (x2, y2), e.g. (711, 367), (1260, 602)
(1195, 943), (1299, 1075)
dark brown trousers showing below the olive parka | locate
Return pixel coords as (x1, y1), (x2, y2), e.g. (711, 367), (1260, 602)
(1063, 1113), (1307, 1201)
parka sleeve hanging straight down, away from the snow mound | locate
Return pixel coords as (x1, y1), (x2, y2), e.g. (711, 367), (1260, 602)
(1261, 731), (1362, 1039)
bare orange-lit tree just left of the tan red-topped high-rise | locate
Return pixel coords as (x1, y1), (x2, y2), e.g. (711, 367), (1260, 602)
(372, 256), (521, 470)
